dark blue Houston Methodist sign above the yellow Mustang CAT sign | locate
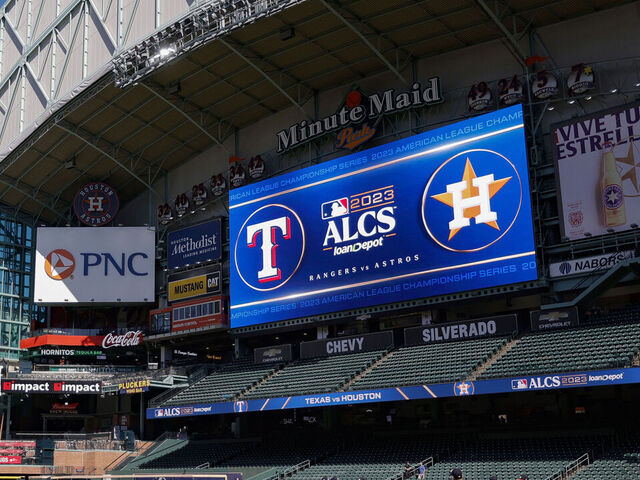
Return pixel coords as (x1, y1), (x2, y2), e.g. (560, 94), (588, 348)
(167, 219), (221, 268)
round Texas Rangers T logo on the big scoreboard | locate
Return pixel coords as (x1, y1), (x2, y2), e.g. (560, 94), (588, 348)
(234, 204), (305, 291)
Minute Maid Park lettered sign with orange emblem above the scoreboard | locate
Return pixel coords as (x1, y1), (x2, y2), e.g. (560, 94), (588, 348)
(276, 77), (444, 153)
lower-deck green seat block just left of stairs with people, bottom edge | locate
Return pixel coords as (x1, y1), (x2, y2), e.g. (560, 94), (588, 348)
(292, 438), (451, 480)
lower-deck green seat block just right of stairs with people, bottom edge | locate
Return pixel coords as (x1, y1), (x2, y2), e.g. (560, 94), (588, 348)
(425, 436), (604, 480)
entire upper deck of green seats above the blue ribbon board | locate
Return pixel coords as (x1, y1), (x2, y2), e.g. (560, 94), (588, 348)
(158, 310), (640, 406)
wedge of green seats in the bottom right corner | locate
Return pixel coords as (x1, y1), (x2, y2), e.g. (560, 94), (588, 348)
(571, 435), (640, 480)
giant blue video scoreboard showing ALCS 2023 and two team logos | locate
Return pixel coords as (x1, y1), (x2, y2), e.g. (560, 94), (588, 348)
(229, 105), (538, 328)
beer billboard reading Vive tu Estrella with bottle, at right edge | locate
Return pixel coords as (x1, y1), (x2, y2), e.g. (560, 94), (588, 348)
(554, 104), (640, 240)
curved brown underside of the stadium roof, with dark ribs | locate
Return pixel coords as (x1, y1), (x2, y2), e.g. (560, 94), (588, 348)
(0, 0), (631, 224)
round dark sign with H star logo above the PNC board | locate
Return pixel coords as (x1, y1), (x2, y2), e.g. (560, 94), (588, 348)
(73, 182), (120, 227)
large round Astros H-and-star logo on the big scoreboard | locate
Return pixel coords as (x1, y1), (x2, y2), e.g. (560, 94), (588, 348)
(422, 149), (523, 252)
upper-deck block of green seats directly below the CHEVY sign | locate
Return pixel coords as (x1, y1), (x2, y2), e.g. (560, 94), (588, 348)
(242, 351), (384, 398)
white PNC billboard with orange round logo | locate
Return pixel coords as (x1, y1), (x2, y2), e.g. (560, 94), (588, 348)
(33, 227), (155, 304)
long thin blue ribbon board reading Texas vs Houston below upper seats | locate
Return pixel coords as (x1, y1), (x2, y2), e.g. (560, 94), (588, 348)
(147, 367), (640, 419)
